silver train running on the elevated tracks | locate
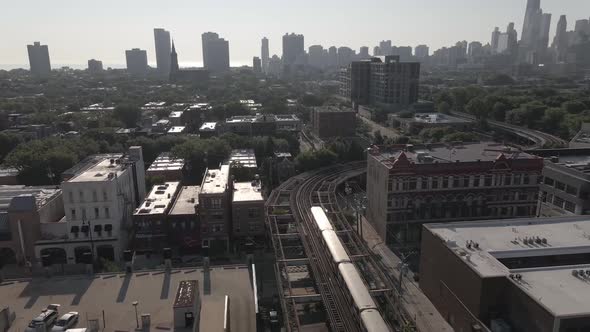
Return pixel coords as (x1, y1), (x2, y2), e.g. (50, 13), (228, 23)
(311, 206), (391, 332)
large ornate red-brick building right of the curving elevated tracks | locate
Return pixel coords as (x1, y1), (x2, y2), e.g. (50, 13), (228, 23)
(367, 143), (543, 247)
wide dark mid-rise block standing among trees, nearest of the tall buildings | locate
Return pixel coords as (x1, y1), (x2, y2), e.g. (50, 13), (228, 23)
(340, 55), (420, 109)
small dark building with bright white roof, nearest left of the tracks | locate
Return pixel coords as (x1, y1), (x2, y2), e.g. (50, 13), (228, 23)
(232, 181), (264, 243)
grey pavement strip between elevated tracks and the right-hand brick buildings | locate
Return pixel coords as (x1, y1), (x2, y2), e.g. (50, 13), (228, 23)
(362, 217), (453, 332)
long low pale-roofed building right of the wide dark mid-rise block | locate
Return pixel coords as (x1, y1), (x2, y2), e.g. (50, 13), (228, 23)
(389, 113), (473, 135)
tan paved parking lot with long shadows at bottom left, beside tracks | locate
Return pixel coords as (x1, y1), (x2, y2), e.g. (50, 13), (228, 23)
(0, 266), (256, 332)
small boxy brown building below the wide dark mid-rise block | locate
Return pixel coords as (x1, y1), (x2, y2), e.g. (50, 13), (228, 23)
(311, 106), (356, 138)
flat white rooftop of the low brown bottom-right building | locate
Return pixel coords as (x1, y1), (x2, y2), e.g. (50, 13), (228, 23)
(425, 216), (590, 317)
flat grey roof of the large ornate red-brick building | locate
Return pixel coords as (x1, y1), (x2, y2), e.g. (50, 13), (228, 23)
(371, 142), (540, 167)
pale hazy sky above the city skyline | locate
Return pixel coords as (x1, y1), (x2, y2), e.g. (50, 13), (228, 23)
(0, 0), (590, 68)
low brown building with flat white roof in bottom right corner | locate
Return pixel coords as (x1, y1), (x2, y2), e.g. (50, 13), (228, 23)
(420, 216), (590, 332)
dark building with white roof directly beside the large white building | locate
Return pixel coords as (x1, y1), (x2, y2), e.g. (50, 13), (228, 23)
(133, 182), (180, 251)
